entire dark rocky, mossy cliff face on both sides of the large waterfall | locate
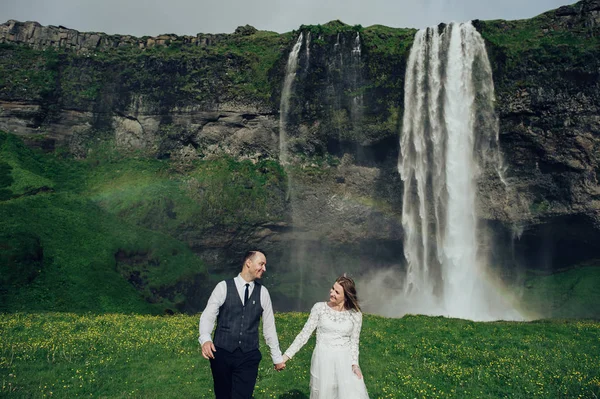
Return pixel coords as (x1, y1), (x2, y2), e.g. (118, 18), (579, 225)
(0, 0), (600, 311)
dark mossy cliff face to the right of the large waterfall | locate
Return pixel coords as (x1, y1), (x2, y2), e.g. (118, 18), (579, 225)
(476, 0), (600, 270)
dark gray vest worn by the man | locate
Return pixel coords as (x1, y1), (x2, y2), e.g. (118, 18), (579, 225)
(214, 279), (263, 352)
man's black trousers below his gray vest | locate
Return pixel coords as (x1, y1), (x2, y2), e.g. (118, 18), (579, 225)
(210, 347), (262, 399)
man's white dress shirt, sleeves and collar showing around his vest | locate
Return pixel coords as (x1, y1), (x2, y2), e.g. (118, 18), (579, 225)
(198, 274), (283, 364)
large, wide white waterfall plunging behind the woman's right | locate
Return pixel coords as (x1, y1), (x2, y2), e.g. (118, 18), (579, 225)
(398, 23), (519, 320)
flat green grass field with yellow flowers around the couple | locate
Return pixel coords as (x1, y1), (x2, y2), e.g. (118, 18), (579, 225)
(0, 313), (600, 399)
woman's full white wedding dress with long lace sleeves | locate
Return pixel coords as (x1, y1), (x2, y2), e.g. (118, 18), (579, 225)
(285, 302), (369, 399)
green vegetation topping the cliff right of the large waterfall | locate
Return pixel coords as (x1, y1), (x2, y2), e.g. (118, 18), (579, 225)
(475, 2), (600, 89)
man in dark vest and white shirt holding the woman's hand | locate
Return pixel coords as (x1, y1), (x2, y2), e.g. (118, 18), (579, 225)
(198, 251), (285, 399)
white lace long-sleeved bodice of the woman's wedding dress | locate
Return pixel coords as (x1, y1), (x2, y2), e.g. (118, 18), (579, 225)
(285, 302), (362, 365)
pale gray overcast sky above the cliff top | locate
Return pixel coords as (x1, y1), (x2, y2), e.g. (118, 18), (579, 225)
(0, 0), (574, 36)
